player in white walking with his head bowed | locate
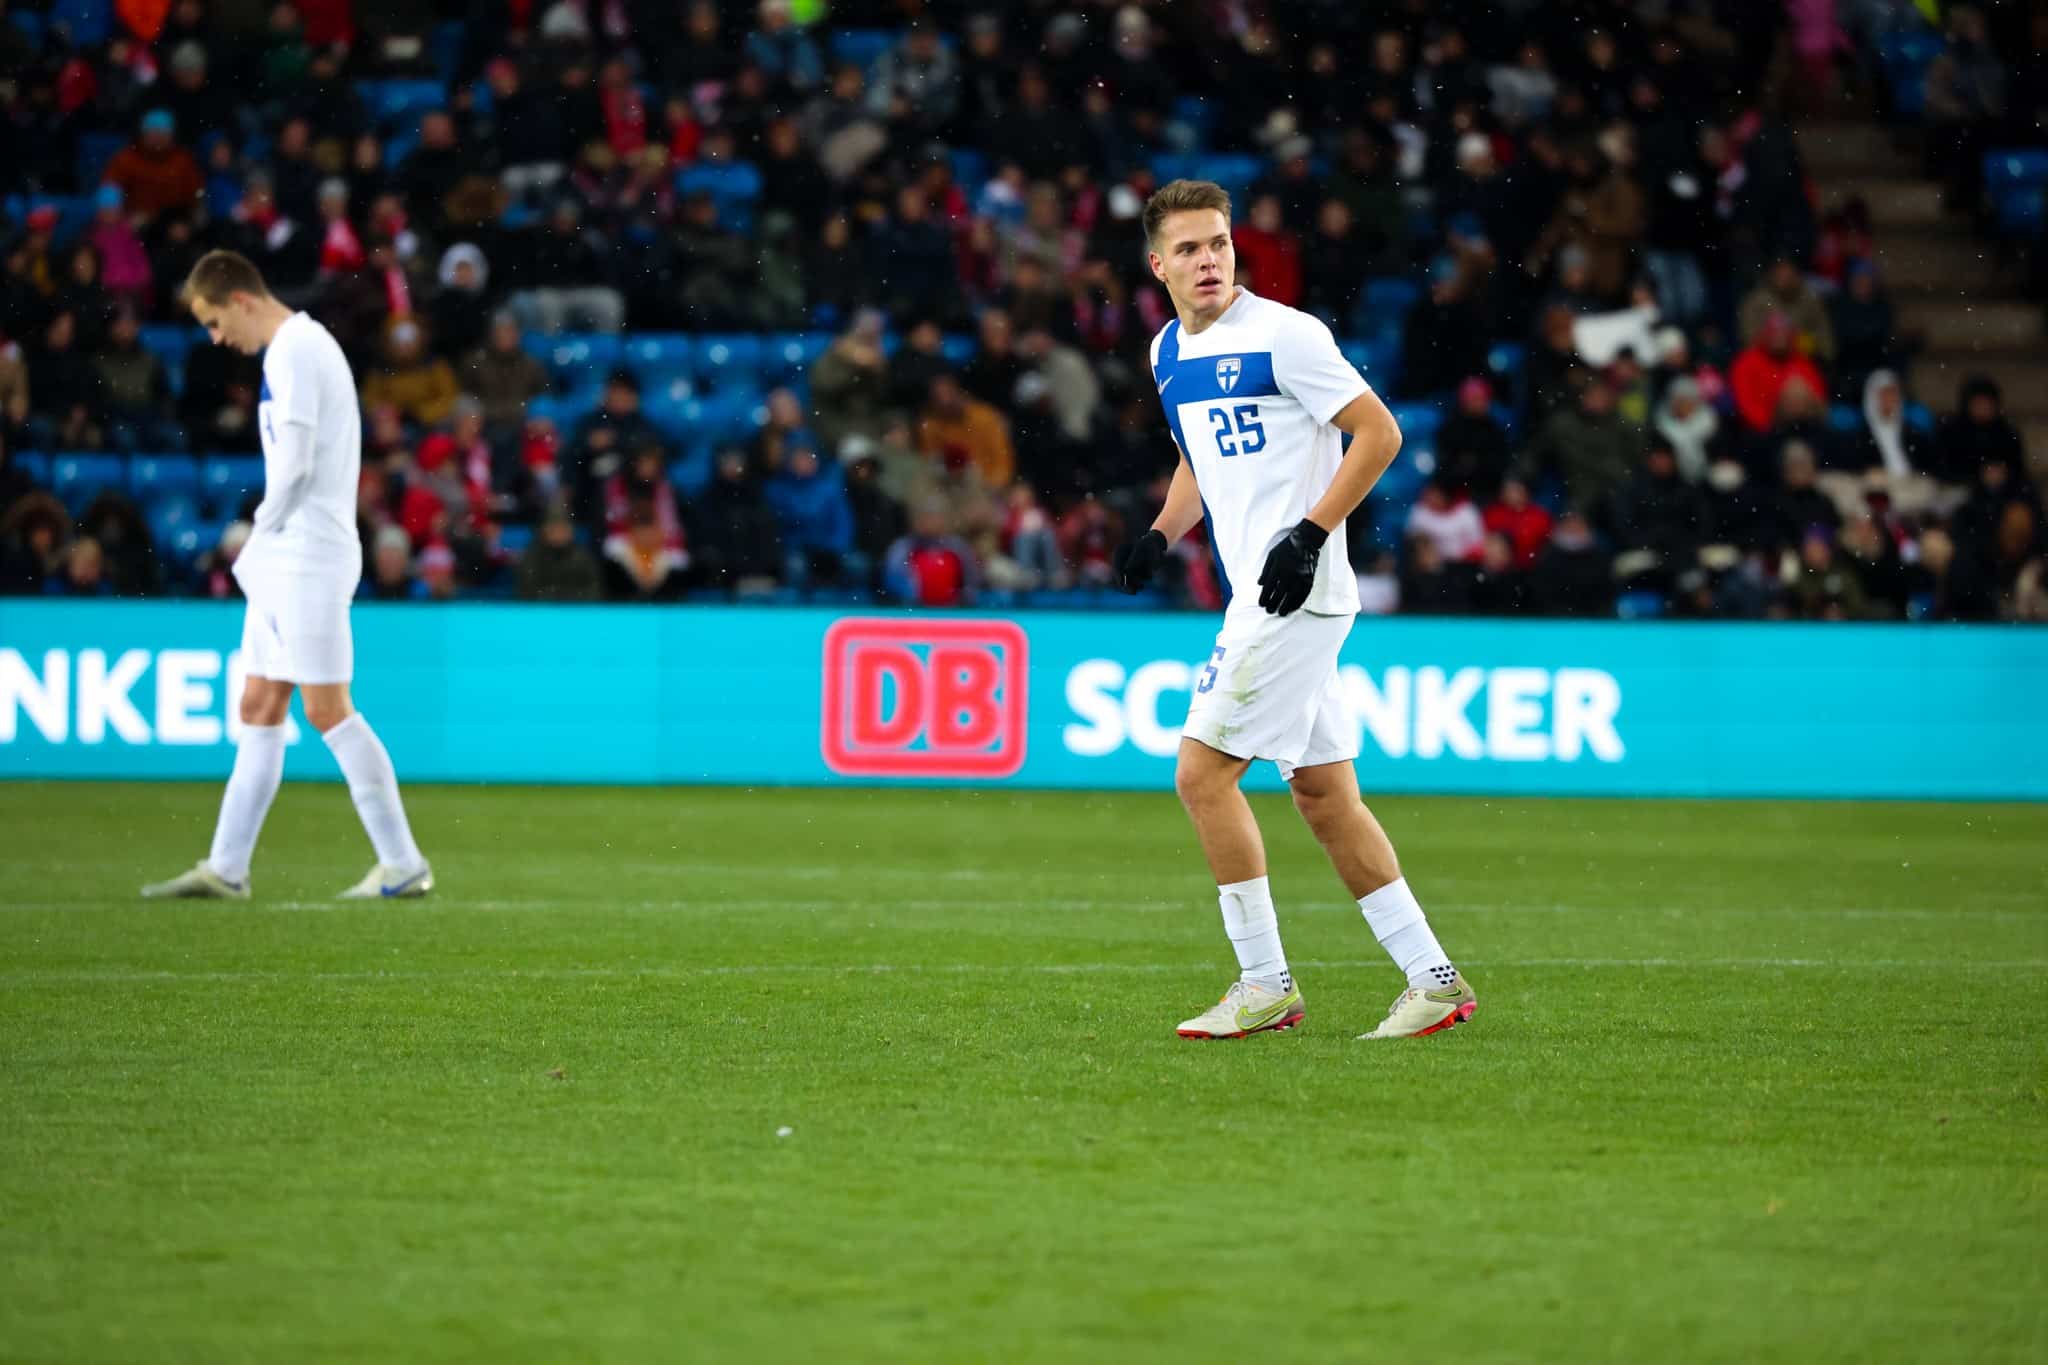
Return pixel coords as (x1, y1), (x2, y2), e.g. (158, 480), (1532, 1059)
(141, 252), (434, 900)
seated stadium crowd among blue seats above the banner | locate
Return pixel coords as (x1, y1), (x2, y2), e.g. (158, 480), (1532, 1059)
(0, 0), (2048, 620)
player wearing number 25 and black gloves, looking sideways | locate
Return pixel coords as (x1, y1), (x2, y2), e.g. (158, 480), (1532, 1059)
(1116, 180), (1479, 1038)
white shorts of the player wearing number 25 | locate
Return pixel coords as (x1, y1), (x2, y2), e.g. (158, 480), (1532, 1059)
(1182, 612), (1358, 782)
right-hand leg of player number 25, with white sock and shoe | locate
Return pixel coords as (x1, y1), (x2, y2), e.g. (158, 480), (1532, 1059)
(1288, 753), (1479, 1038)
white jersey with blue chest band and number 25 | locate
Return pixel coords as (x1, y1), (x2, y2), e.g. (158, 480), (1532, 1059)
(1151, 287), (1366, 616)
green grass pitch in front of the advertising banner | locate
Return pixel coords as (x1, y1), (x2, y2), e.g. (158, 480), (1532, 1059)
(0, 784), (2048, 1365)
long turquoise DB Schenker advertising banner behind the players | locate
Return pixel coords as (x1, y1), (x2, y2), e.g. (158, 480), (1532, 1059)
(0, 600), (2048, 800)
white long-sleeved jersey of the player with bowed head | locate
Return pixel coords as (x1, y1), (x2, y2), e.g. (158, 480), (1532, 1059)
(236, 313), (362, 591)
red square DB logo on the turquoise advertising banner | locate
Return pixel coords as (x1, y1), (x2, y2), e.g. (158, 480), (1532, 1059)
(821, 616), (1028, 778)
